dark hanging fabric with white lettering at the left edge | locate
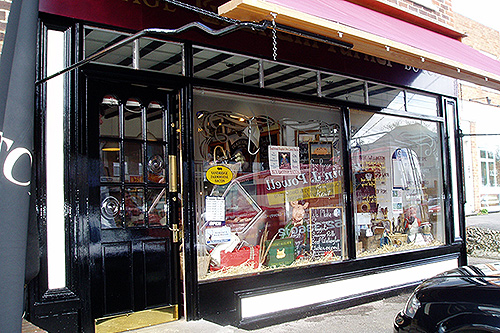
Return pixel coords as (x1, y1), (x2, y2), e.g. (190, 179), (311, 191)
(0, 0), (38, 332)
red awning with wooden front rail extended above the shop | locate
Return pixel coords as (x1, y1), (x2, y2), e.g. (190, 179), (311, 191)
(219, 0), (500, 90)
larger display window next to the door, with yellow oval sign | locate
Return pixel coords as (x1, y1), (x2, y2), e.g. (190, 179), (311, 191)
(194, 89), (346, 280)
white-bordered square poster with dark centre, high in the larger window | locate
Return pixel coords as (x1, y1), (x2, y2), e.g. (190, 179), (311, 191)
(268, 146), (300, 175)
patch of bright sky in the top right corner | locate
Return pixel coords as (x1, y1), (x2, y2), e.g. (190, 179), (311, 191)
(452, 0), (500, 31)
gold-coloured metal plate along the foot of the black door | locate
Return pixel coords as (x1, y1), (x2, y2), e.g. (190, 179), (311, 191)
(95, 304), (179, 333)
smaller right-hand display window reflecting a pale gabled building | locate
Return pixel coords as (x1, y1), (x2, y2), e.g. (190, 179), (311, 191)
(350, 110), (445, 257)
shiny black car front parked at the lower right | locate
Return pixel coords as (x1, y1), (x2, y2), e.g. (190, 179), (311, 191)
(394, 262), (500, 333)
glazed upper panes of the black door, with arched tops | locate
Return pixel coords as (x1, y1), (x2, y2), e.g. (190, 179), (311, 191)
(99, 94), (168, 229)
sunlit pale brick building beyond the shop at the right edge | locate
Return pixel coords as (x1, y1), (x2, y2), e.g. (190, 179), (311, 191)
(454, 14), (500, 214)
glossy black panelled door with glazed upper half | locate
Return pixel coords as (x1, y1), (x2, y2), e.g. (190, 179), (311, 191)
(86, 79), (179, 319)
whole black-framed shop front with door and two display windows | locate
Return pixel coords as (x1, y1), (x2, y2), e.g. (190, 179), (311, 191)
(28, 0), (488, 332)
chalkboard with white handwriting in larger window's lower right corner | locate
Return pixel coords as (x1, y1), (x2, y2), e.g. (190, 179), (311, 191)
(309, 207), (342, 257)
